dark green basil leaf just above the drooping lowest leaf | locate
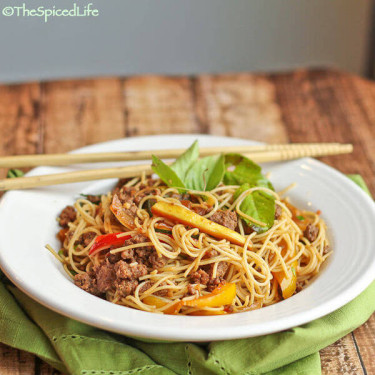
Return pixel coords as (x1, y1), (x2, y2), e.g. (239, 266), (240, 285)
(224, 153), (274, 190)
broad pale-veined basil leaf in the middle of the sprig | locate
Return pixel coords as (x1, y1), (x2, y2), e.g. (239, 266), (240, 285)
(185, 155), (225, 191)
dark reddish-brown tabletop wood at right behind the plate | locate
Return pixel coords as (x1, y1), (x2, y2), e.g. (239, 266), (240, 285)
(273, 71), (375, 194)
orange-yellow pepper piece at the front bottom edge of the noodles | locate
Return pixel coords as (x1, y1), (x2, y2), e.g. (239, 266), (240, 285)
(180, 283), (236, 307)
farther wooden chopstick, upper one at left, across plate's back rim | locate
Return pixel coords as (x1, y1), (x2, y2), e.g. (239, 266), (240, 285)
(0, 143), (350, 168)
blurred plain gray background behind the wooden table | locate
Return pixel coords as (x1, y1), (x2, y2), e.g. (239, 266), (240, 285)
(0, 0), (372, 82)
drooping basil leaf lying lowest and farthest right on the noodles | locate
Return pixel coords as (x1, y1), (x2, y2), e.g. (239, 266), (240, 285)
(233, 184), (275, 233)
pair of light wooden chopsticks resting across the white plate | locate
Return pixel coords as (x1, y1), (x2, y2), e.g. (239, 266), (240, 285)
(0, 143), (353, 191)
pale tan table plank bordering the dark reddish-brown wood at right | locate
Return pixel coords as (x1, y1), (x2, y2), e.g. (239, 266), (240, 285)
(196, 74), (288, 143)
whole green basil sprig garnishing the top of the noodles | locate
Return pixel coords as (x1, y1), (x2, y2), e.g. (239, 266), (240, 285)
(152, 141), (275, 233)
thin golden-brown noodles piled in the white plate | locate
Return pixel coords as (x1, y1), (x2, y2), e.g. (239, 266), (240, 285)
(47, 175), (330, 314)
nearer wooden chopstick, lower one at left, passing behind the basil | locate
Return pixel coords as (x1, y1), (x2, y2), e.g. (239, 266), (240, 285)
(0, 144), (353, 190)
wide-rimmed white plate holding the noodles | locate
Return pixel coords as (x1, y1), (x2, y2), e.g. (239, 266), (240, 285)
(0, 135), (375, 341)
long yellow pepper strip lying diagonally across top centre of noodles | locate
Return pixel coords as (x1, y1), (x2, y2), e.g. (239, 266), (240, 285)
(151, 202), (246, 246)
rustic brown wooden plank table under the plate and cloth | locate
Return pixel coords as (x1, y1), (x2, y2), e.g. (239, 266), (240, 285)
(0, 70), (375, 375)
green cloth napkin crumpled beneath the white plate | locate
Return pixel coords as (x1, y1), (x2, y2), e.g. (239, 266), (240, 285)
(0, 176), (375, 375)
